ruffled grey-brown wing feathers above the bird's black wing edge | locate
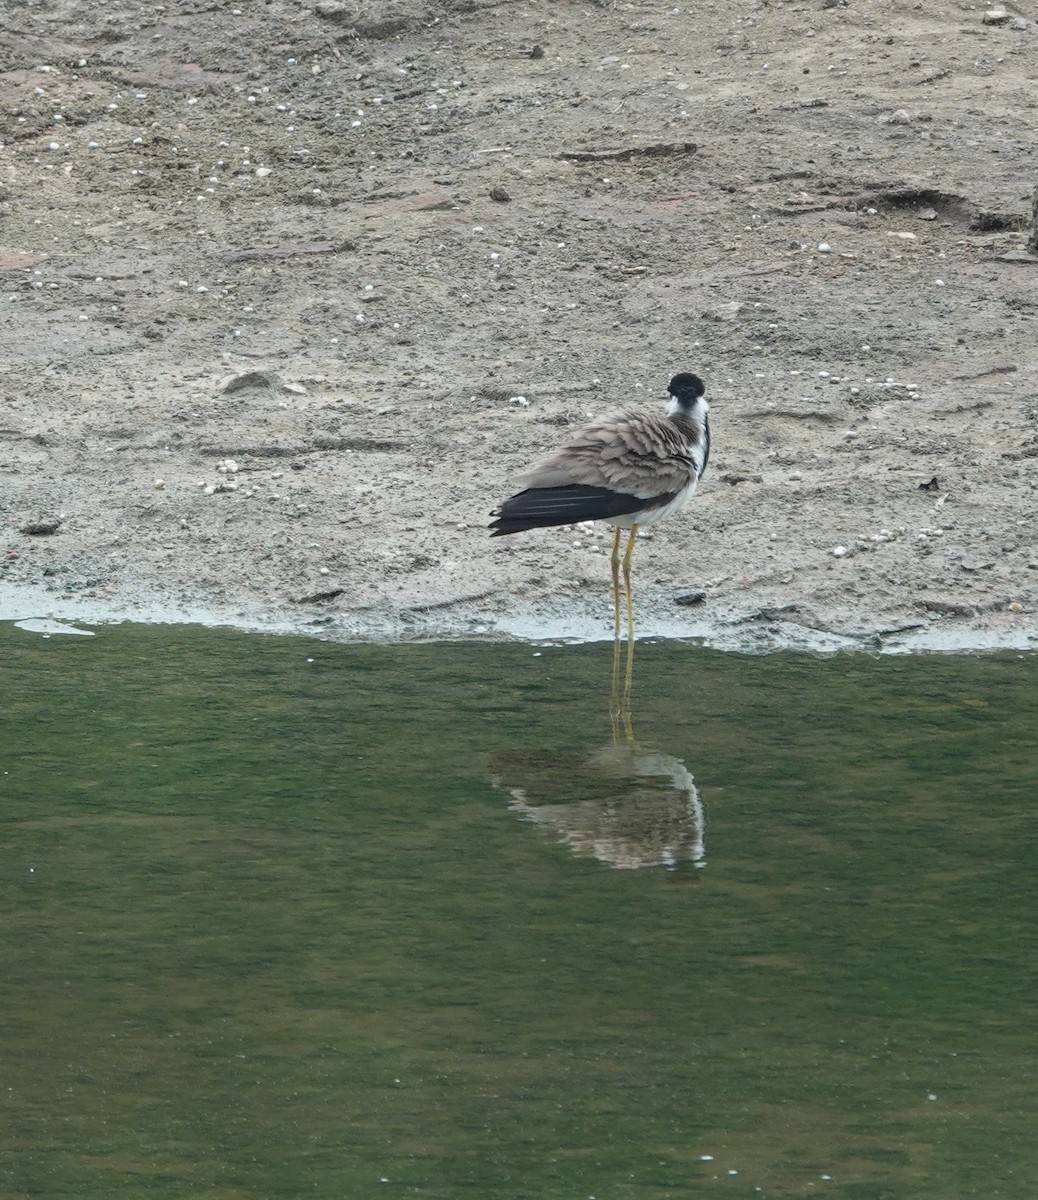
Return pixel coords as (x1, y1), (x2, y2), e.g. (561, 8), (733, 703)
(518, 413), (696, 500)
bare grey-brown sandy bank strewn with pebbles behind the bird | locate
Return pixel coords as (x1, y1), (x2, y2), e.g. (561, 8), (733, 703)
(0, 0), (1038, 648)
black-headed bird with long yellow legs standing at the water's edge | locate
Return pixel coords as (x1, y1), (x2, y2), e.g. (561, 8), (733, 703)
(490, 372), (710, 694)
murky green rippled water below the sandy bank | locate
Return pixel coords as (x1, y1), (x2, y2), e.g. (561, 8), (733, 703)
(0, 626), (1038, 1200)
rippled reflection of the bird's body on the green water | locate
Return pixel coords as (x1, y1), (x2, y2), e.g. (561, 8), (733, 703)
(493, 677), (706, 870)
